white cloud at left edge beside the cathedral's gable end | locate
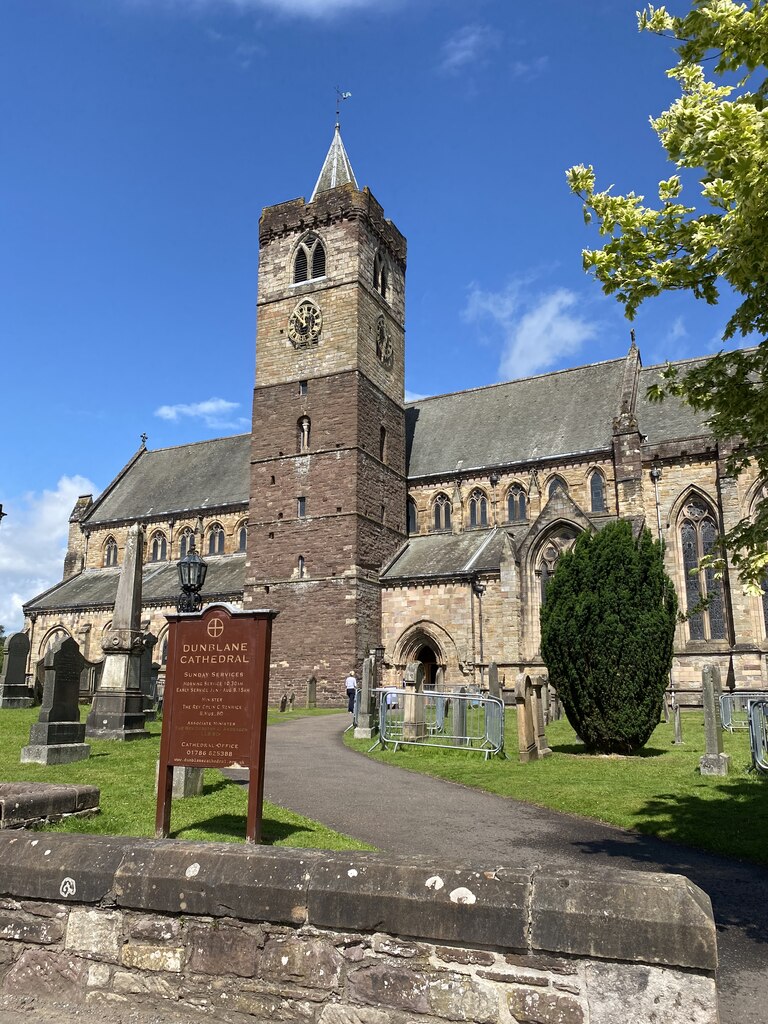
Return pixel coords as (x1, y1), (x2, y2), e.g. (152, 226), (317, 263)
(0, 476), (97, 633)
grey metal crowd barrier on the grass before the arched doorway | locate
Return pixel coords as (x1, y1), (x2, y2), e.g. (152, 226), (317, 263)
(371, 687), (504, 759)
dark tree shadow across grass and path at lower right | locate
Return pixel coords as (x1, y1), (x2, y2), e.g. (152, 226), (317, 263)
(573, 778), (768, 950)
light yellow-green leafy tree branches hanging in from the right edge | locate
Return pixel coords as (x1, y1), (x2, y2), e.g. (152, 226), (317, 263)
(567, 0), (768, 590)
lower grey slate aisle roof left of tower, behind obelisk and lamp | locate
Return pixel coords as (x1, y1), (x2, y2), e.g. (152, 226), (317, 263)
(25, 552), (246, 611)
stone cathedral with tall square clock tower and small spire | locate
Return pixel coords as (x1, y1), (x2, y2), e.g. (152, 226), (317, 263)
(25, 126), (768, 703)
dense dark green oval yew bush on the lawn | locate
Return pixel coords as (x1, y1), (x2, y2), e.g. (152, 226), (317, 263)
(542, 521), (677, 754)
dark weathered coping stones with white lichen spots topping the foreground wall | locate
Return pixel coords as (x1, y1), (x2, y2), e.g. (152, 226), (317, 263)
(0, 833), (717, 972)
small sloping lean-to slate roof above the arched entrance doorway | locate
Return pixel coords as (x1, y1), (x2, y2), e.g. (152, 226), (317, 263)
(382, 528), (506, 583)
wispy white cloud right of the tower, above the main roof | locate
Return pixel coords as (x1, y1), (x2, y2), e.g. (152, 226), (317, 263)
(462, 280), (597, 380)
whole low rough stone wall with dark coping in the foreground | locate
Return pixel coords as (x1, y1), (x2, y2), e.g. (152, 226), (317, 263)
(0, 833), (718, 1024)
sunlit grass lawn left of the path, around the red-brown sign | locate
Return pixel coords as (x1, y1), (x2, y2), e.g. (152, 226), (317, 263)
(0, 708), (371, 850)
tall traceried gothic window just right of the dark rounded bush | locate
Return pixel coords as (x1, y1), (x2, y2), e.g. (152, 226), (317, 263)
(680, 498), (725, 640)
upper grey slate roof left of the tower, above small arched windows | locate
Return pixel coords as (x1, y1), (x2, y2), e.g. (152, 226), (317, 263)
(86, 434), (251, 524)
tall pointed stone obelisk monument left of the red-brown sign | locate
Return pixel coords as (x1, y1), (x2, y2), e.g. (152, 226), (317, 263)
(85, 523), (150, 739)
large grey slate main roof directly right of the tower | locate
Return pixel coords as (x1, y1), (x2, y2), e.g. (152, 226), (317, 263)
(406, 358), (626, 478)
